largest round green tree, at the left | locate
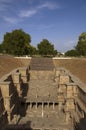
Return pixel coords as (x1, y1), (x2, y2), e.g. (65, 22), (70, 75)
(2, 29), (31, 56)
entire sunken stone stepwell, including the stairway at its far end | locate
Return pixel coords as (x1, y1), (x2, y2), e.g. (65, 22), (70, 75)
(0, 58), (86, 130)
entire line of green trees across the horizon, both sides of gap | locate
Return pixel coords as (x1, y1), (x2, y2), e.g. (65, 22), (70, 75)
(0, 29), (86, 56)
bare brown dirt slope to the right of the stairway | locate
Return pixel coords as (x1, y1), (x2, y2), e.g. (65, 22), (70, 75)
(54, 58), (86, 83)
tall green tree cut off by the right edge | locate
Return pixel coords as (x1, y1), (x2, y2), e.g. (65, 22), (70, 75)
(75, 32), (86, 56)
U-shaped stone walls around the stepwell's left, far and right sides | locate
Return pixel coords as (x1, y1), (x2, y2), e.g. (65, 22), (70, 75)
(0, 67), (86, 130)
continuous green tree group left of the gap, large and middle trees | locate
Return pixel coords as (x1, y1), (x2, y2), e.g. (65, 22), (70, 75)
(0, 29), (57, 56)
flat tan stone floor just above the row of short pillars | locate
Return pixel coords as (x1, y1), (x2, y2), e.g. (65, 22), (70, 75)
(27, 79), (58, 100)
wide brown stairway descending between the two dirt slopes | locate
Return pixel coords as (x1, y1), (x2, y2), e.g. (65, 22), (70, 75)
(30, 58), (54, 70)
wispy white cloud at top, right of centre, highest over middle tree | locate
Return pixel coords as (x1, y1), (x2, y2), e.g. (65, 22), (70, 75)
(38, 2), (60, 10)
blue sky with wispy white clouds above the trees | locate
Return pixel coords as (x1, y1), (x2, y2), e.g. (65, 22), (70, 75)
(0, 0), (86, 52)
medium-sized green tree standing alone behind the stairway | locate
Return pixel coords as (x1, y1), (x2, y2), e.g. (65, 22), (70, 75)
(37, 39), (57, 56)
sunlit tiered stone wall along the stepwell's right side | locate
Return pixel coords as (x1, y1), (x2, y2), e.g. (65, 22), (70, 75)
(55, 68), (86, 130)
